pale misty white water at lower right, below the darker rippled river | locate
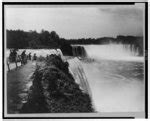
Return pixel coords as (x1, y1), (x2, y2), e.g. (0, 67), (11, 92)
(82, 61), (144, 112)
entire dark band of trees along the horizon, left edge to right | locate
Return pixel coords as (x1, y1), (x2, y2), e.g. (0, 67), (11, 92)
(6, 30), (143, 55)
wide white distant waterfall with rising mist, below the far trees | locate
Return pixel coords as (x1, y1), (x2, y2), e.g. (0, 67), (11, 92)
(73, 43), (144, 61)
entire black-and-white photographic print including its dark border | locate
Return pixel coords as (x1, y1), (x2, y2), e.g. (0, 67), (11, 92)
(4, 3), (146, 118)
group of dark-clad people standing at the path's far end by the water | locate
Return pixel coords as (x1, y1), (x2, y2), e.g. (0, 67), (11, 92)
(9, 49), (37, 65)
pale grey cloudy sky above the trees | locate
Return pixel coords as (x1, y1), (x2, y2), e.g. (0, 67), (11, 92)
(5, 3), (144, 39)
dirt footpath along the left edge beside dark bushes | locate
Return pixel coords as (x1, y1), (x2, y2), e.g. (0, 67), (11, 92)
(6, 61), (35, 113)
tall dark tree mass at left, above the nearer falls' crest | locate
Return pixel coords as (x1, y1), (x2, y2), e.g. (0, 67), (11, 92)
(6, 30), (72, 55)
